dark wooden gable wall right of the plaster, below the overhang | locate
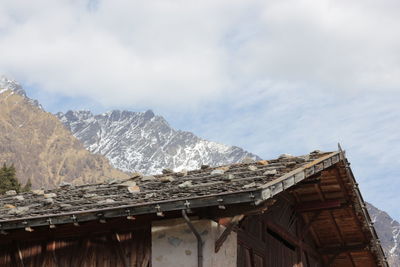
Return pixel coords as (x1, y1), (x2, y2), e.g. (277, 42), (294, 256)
(237, 196), (322, 267)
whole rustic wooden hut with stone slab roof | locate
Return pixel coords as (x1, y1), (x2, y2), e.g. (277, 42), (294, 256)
(0, 149), (388, 267)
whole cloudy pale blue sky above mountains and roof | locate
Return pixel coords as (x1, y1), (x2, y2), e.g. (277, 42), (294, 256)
(0, 0), (400, 219)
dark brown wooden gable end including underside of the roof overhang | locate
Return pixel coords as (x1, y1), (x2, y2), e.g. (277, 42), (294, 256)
(238, 162), (382, 267)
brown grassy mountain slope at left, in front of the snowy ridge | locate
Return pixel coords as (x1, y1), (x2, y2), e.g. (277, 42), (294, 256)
(0, 77), (127, 188)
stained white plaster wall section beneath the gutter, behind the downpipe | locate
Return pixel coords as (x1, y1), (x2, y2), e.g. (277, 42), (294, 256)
(151, 218), (237, 267)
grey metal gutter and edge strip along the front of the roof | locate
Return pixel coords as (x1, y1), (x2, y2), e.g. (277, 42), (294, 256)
(0, 152), (342, 232)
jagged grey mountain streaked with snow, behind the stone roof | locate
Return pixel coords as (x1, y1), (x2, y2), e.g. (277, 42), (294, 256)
(56, 110), (258, 174)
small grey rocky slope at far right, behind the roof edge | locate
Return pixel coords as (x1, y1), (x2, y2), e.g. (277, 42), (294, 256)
(367, 203), (400, 267)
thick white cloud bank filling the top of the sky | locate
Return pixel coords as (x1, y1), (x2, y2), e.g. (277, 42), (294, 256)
(0, 0), (400, 109)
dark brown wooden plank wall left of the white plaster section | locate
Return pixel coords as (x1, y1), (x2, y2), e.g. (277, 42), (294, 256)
(0, 221), (151, 267)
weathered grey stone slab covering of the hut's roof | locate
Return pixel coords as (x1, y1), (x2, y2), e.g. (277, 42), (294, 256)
(0, 151), (332, 229)
